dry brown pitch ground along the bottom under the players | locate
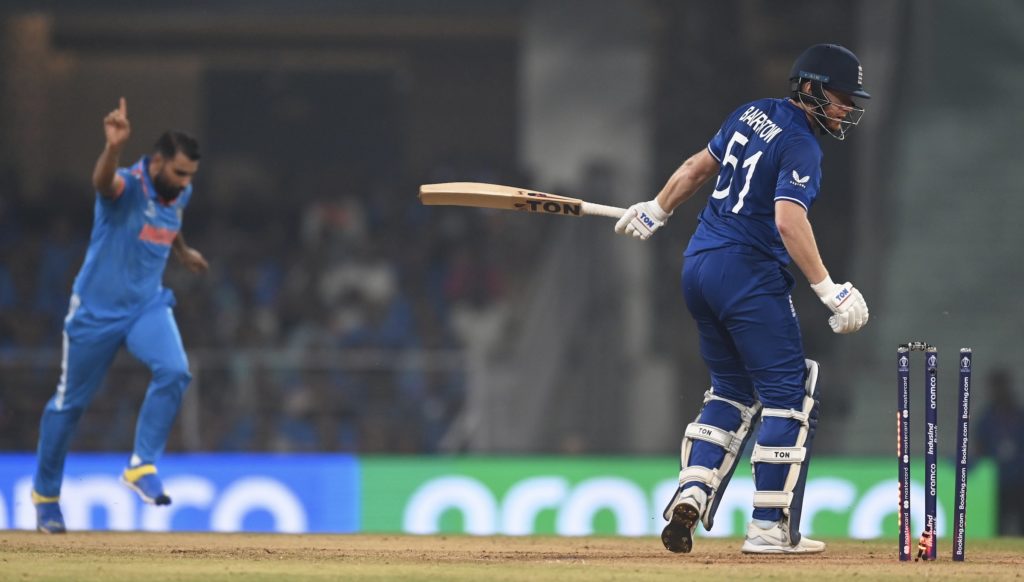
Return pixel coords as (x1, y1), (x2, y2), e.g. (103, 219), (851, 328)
(0, 531), (1024, 582)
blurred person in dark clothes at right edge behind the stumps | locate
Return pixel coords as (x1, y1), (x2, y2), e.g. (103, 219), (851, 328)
(976, 368), (1024, 536)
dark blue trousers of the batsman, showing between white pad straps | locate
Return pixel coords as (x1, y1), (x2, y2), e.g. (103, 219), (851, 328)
(682, 246), (806, 521)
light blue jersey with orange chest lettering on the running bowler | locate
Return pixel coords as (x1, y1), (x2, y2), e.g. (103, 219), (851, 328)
(73, 156), (191, 320)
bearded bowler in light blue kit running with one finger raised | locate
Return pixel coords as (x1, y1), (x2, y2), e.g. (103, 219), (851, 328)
(32, 97), (209, 534)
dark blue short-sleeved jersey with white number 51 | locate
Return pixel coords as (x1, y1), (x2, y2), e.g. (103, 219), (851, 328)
(685, 98), (821, 264)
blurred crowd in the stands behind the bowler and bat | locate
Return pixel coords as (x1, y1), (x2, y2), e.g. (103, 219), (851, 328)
(0, 159), (552, 453)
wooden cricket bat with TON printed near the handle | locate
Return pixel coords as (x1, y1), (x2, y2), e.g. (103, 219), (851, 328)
(420, 182), (626, 218)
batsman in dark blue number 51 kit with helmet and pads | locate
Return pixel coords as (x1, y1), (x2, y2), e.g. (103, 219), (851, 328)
(615, 44), (870, 553)
